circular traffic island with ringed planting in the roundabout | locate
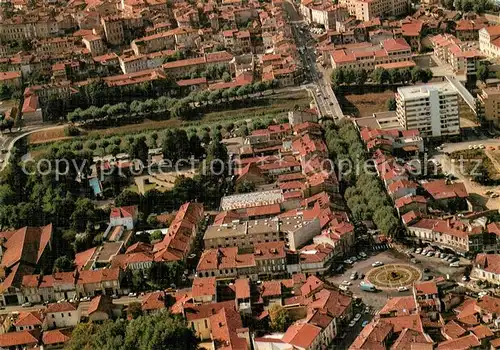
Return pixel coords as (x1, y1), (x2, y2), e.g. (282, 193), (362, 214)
(365, 264), (422, 290)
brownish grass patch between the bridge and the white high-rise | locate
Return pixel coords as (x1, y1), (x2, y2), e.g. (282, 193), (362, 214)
(337, 90), (394, 117)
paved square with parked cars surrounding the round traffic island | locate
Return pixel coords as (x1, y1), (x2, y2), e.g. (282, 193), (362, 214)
(328, 249), (465, 311)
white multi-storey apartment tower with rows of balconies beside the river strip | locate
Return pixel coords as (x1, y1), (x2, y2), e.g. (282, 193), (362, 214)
(396, 83), (460, 137)
